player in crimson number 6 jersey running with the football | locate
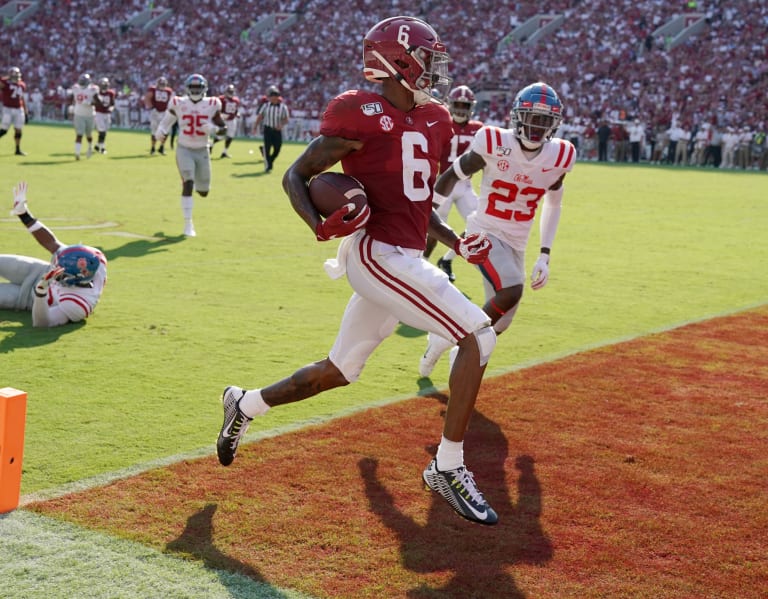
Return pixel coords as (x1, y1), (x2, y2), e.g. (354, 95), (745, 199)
(217, 16), (498, 524)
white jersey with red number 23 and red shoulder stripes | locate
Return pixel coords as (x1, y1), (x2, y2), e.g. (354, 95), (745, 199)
(467, 127), (576, 251)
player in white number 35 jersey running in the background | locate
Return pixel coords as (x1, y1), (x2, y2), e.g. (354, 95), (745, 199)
(155, 73), (227, 237)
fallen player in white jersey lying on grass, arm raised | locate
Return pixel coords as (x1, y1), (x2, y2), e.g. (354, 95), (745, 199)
(0, 181), (107, 327)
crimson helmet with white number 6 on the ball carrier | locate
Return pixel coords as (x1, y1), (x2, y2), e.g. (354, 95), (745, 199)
(363, 17), (451, 104)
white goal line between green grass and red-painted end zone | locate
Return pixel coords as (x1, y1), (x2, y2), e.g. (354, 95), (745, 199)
(19, 301), (768, 507)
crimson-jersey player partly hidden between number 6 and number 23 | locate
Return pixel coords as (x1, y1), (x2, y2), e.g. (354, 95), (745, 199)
(424, 85), (483, 281)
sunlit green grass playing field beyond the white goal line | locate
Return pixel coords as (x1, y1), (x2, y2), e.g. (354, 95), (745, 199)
(0, 125), (768, 596)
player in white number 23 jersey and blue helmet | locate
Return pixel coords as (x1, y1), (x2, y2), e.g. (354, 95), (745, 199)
(419, 82), (576, 376)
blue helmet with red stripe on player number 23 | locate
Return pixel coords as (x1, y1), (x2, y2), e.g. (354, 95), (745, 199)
(510, 81), (563, 150)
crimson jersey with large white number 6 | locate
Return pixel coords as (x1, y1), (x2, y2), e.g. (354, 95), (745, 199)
(320, 90), (453, 250)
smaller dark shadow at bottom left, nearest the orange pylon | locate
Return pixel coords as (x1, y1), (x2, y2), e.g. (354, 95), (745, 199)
(165, 503), (294, 599)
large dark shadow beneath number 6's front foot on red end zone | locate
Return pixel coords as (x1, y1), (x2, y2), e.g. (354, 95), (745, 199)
(358, 393), (553, 599)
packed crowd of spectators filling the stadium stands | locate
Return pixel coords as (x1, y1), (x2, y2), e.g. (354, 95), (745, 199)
(0, 0), (768, 168)
